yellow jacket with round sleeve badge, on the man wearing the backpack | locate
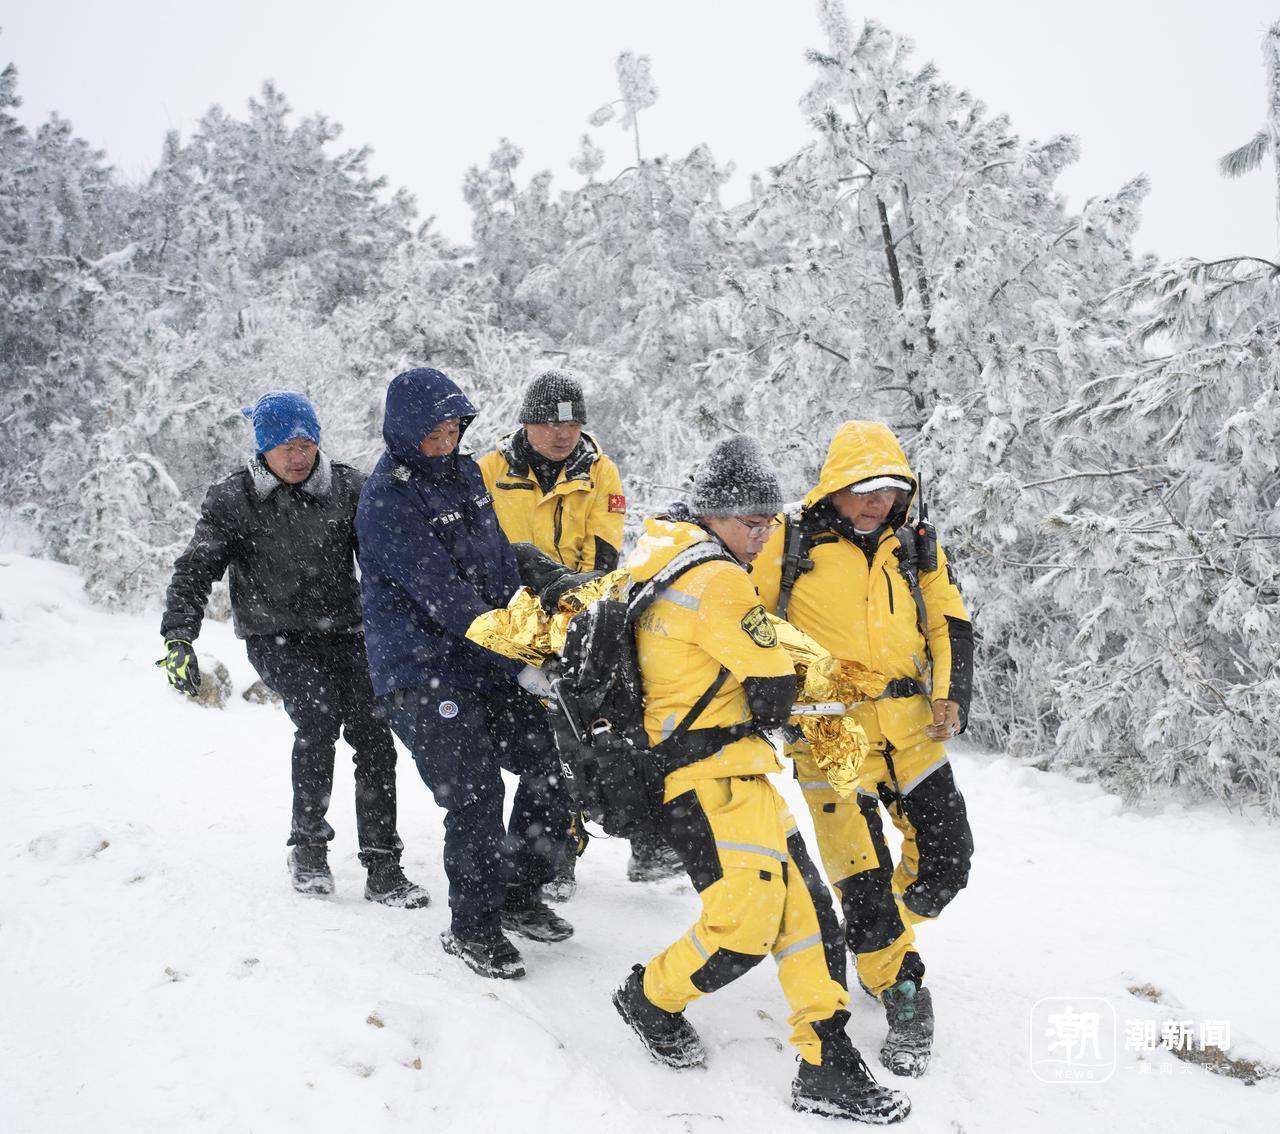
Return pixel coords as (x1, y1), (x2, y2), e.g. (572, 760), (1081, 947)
(626, 517), (795, 799)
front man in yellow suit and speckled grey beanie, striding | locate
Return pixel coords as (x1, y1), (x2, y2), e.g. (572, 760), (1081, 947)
(613, 436), (910, 1122)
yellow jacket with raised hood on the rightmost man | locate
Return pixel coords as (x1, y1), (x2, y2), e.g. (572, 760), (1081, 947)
(753, 421), (973, 749)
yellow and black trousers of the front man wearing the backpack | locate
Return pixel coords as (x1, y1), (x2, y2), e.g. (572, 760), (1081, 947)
(644, 776), (849, 1064)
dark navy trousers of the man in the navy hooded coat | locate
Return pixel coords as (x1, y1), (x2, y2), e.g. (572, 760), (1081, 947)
(381, 683), (570, 937)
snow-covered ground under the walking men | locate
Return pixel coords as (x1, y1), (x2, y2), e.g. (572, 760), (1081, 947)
(0, 555), (1280, 1134)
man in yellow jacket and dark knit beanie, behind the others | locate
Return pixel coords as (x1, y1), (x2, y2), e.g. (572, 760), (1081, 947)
(479, 369), (682, 901)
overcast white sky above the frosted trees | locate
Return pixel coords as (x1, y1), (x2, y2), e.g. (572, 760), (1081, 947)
(0, 0), (1280, 259)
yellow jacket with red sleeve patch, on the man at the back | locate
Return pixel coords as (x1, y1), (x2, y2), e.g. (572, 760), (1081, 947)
(479, 433), (627, 571)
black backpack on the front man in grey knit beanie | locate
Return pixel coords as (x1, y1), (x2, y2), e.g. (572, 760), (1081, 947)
(552, 540), (755, 837)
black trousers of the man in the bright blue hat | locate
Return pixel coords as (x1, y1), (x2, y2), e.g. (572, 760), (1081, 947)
(244, 634), (403, 866)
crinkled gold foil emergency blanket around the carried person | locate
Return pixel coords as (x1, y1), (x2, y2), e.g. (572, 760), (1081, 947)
(467, 571), (888, 796)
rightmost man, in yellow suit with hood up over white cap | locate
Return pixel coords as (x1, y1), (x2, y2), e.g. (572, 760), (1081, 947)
(754, 421), (973, 1075)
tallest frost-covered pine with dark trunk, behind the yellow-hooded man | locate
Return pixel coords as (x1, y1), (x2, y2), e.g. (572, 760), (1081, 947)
(691, 8), (1146, 751)
